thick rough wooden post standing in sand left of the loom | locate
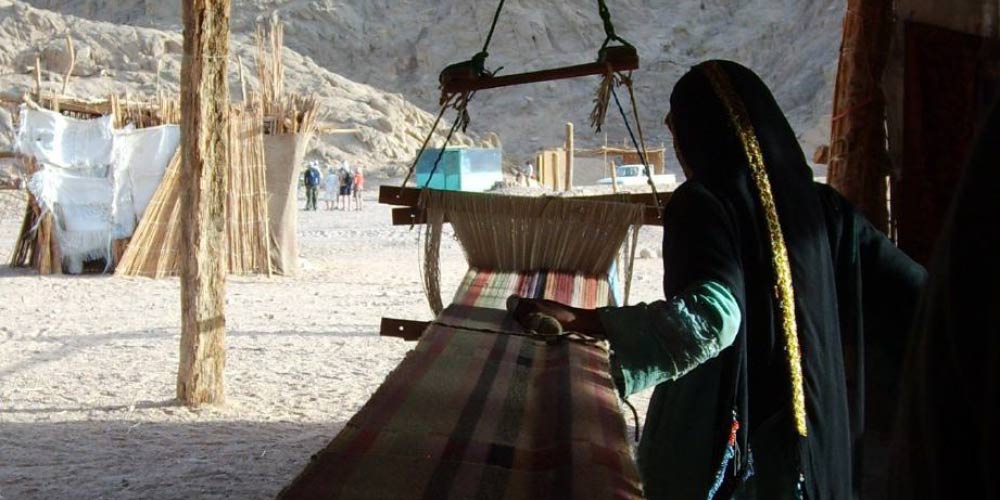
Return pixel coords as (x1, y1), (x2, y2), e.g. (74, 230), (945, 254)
(177, 0), (230, 406)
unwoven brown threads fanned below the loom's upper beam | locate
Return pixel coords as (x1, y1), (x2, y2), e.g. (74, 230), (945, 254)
(420, 189), (644, 314)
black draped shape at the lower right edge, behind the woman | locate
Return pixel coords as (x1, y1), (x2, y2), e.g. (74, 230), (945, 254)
(890, 99), (1000, 499)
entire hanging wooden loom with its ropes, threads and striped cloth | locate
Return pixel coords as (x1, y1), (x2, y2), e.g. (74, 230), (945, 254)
(279, 0), (665, 499)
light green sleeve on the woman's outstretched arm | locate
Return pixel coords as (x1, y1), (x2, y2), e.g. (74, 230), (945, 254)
(598, 281), (742, 396)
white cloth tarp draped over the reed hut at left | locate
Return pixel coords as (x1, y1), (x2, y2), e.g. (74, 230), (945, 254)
(15, 106), (180, 273)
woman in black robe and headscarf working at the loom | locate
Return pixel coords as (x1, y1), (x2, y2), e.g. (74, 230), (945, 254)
(515, 61), (925, 499)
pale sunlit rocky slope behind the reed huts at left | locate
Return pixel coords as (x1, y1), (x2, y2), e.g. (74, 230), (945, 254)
(0, 0), (480, 176)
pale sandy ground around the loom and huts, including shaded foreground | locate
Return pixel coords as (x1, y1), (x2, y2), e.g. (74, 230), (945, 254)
(0, 188), (662, 500)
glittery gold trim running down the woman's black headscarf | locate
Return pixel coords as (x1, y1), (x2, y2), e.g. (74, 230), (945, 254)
(702, 62), (808, 437)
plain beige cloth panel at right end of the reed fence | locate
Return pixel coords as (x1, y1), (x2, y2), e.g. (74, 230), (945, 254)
(264, 134), (311, 275)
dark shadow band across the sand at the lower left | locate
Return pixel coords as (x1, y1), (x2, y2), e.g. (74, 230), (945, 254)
(0, 418), (344, 499)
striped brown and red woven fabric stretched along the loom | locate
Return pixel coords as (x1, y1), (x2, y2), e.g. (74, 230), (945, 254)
(280, 272), (642, 499)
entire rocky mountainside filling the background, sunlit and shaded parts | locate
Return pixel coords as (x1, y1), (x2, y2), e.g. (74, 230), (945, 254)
(0, 0), (844, 176)
